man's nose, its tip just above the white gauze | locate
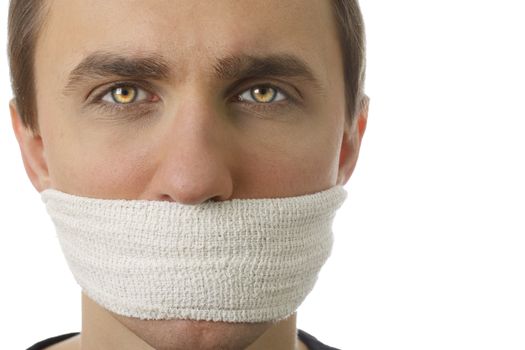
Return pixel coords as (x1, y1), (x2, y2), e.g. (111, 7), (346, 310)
(143, 103), (234, 205)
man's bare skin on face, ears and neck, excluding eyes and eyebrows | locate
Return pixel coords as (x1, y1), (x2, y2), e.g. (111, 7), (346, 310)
(11, 0), (368, 350)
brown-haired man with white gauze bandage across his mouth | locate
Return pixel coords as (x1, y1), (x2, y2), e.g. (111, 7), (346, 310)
(9, 0), (368, 350)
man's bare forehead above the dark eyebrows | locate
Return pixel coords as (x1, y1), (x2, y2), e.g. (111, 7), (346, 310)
(35, 0), (340, 91)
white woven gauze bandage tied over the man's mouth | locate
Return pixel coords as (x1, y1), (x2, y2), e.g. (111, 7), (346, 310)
(42, 185), (347, 322)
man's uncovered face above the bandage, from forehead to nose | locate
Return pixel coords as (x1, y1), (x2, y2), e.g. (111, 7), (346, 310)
(16, 0), (359, 204)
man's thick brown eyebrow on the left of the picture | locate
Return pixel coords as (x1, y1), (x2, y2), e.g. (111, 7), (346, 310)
(64, 51), (170, 95)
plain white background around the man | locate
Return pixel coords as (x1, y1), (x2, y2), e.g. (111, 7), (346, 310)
(0, 0), (525, 350)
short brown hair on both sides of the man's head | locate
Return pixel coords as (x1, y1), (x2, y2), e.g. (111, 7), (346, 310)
(8, 0), (368, 133)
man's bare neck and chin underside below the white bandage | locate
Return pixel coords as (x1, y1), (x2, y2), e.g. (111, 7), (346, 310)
(81, 294), (306, 350)
